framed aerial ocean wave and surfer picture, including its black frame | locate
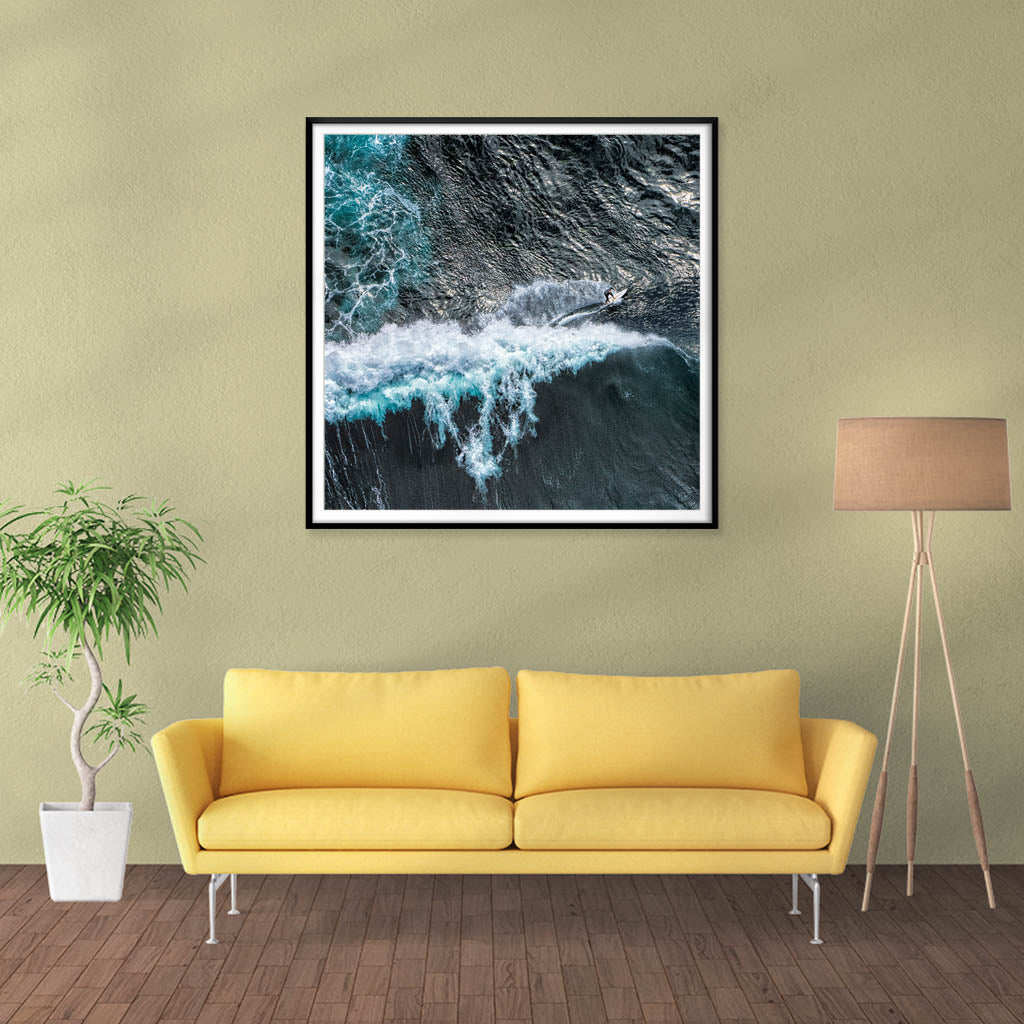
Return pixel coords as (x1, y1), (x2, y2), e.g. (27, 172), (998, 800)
(306, 118), (718, 528)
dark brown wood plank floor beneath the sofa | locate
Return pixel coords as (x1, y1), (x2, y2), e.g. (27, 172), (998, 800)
(0, 865), (1024, 1024)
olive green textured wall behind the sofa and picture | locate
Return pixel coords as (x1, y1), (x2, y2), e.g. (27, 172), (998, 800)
(0, 0), (1024, 861)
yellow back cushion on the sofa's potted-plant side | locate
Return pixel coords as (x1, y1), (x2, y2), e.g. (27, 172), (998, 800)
(219, 669), (512, 797)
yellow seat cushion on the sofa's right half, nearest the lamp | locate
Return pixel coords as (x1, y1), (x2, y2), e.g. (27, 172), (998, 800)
(515, 788), (831, 850)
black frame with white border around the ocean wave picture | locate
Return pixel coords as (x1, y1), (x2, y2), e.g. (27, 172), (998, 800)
(305, 117), (719, 529)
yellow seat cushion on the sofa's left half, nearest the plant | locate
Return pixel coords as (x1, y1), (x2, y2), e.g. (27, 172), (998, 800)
(199, 788), (512, 850)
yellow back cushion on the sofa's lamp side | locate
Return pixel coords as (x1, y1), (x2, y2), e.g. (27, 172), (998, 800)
(515, 671), (807, 797)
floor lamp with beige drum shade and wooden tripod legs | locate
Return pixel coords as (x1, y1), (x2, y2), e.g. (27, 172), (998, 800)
(835, 417), (1010, 910)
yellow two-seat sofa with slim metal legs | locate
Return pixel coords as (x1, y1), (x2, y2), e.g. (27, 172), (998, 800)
(153, 669), (876, 941)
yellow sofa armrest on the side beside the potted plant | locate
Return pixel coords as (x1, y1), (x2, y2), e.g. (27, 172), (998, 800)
(151, 718), (223, 874)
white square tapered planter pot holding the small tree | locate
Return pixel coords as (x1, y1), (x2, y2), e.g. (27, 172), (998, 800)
(39, 803), (131, 901)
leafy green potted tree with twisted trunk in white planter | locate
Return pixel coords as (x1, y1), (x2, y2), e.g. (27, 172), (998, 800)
(0, 481), (203, 900)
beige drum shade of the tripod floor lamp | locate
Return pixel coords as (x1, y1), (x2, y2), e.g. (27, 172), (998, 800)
(835, 417), (1010, 511)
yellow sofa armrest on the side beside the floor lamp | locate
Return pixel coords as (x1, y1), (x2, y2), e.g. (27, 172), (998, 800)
(801, 718), (879, 874)
